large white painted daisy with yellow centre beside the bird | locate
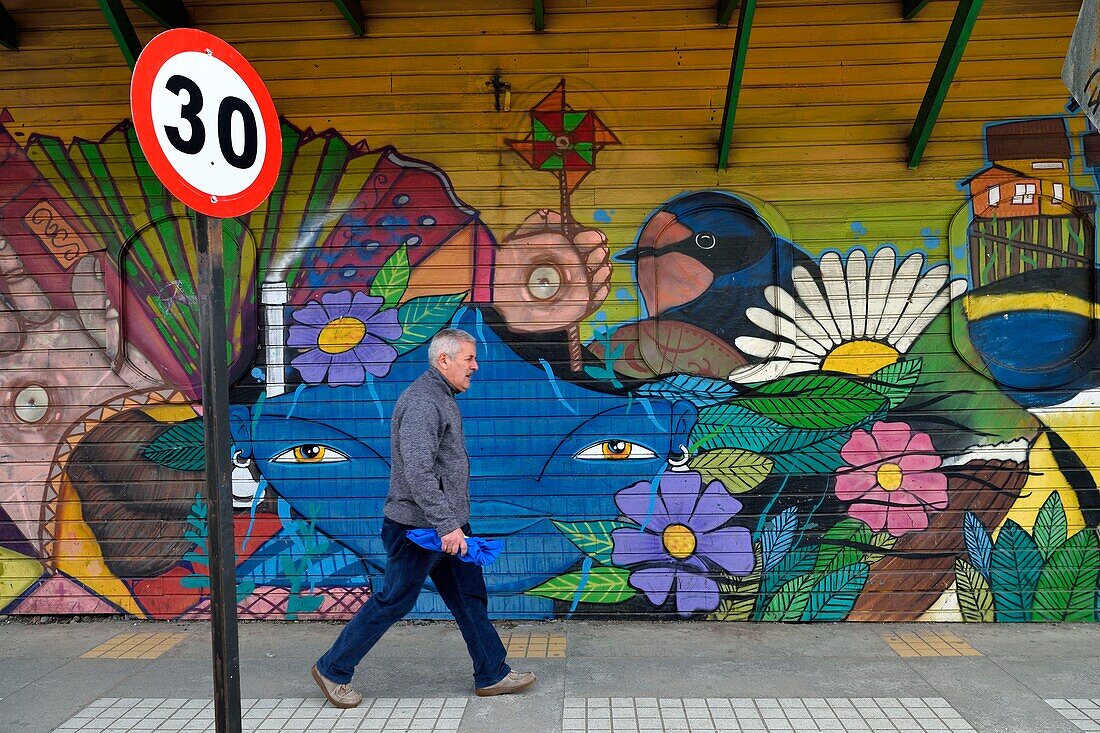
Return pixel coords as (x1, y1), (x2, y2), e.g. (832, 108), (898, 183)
(729, 247), (966, 382)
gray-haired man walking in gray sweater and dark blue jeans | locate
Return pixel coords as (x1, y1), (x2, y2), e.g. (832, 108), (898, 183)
(312, 328), (535, 708)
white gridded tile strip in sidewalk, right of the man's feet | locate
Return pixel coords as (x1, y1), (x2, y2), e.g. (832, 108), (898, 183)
(562, 698), (975, 733)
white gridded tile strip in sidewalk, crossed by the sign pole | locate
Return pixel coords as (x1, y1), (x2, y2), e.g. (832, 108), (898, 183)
(55, 698), (466, 733)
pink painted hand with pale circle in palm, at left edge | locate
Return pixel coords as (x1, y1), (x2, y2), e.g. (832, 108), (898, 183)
(0, 238), (161, 547)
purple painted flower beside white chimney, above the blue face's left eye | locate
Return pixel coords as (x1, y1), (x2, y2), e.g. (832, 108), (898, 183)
(287, 291), (402, 386)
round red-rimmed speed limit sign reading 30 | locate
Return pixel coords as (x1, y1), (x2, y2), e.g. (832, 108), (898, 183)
(130, 28), (283, 218)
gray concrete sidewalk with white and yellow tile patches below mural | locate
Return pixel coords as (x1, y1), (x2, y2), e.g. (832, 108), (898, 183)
(0, 620), (1100, 733)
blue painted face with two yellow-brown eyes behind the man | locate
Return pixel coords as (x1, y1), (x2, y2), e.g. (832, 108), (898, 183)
(232, 305), (695, 605)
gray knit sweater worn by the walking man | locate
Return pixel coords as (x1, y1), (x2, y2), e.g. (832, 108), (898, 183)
(383, 368), (470, 537)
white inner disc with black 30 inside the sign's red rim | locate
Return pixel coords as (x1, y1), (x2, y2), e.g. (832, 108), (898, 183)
(151, 51), (267, 196)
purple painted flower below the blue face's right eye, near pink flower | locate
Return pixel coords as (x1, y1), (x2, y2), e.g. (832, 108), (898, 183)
(612, 464), (756, 616)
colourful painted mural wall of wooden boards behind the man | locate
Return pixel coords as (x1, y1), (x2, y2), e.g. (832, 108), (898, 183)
(0, 0), (1100, 622)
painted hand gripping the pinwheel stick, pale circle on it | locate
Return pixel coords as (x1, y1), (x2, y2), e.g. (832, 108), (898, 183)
(493, 209), (612, 333)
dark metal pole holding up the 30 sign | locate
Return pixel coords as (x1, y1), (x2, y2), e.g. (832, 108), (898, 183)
(195, 212), (241, 733)
